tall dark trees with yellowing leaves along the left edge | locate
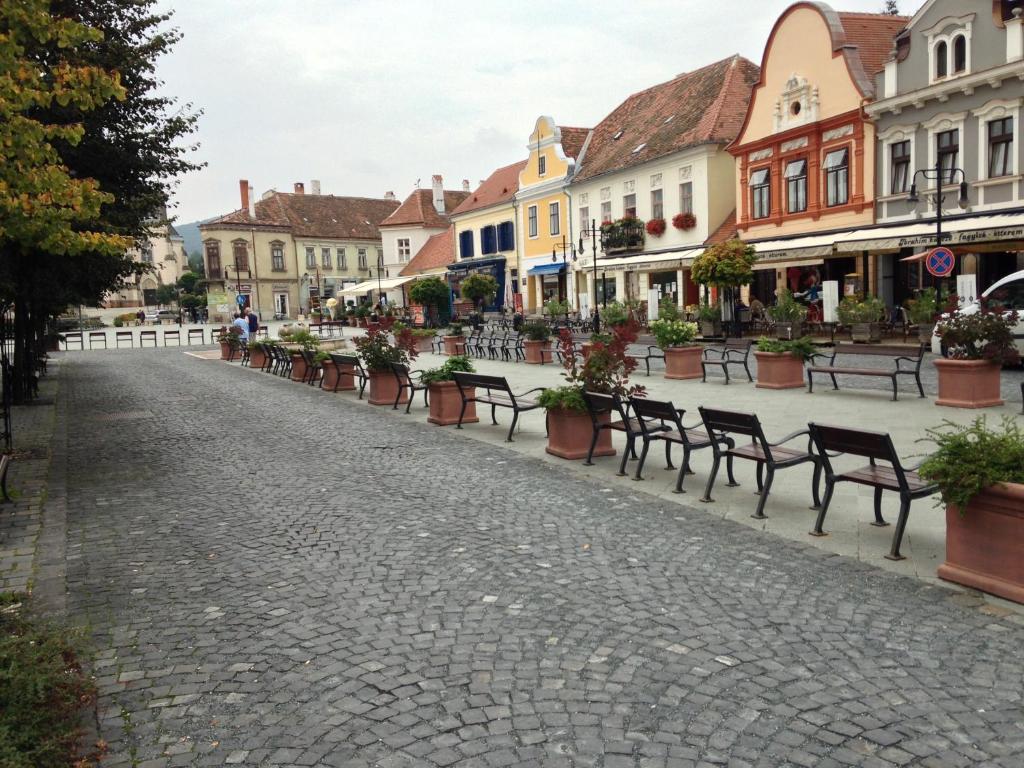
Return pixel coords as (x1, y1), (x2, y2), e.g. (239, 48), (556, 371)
(0, 0), (200, 399)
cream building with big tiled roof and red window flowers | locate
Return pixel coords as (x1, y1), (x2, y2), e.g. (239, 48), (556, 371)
(568, 56), (758, 313)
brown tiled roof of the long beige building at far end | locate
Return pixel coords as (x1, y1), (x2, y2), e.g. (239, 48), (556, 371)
(200, 193), (398, 240)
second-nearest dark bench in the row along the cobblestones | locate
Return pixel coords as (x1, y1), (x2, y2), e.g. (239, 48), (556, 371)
(698, 406), (821, 520)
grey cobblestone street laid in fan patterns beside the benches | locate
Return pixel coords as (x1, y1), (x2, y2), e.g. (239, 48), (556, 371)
(58, 350), (1024, 768)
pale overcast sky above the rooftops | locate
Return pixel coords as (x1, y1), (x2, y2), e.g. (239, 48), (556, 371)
(160, 0), (921, 222)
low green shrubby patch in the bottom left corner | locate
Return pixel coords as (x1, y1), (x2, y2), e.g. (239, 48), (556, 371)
(0, 593), (99, 768)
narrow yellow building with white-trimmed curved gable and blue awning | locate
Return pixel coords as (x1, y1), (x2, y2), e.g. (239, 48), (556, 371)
(515, 116), (590, 312)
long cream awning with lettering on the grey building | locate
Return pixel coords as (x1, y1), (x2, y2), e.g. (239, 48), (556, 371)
(836, 213), (1024, 253)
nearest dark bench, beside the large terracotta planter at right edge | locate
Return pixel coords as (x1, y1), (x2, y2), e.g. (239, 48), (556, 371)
(808, 423), (938, 560)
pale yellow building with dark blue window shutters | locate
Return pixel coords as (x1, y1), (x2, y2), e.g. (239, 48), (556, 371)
(449, 161), (526, 311)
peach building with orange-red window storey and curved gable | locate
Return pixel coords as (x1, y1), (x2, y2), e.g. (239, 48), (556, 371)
(729, 2), (907, 309)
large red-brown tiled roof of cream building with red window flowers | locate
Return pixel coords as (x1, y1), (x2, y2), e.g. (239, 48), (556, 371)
(577, 55), (760, 181)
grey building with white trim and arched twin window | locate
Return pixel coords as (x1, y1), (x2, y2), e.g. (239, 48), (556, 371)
(853, 0), (1024, 304)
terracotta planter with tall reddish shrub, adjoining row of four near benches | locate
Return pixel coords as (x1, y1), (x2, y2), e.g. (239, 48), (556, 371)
(538, 322), (644, 460)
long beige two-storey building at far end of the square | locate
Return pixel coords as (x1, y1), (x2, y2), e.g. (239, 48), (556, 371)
(200, 180), (398, 322)
